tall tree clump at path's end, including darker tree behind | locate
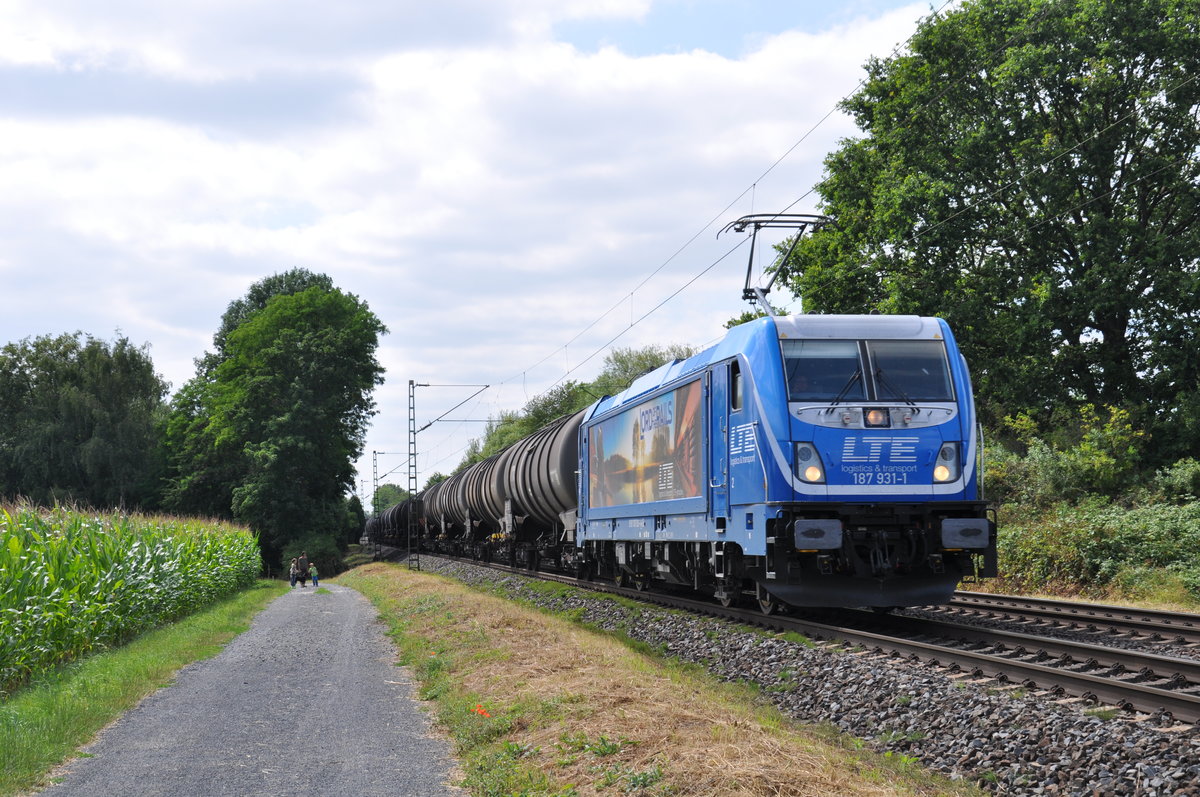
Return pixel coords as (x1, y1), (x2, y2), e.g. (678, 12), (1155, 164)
(168, 272), (386, 561)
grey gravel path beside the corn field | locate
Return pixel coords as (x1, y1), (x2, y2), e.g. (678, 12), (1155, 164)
(42, 585), (463, 797)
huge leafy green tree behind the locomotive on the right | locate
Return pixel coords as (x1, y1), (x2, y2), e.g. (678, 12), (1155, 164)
(785, 0), (1200, 457)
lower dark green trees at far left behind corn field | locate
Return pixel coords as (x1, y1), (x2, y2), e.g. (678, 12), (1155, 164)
(0, 332), (167, 509)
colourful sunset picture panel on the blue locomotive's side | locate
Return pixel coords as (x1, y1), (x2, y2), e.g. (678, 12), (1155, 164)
(588, 380), (704, 508)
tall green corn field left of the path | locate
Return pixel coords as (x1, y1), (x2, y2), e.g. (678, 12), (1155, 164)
(0, 507), (262, 695)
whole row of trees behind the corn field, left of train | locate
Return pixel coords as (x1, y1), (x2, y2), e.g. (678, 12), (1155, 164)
(0, 269), (386, 571)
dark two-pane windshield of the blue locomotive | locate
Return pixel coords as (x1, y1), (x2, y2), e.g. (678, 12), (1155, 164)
(780, 338), (954, 402)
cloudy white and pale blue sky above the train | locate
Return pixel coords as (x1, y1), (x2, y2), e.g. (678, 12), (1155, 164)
(0, 0), (931, 506)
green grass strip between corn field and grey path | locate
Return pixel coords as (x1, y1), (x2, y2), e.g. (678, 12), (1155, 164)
(0, 581), (288, 797)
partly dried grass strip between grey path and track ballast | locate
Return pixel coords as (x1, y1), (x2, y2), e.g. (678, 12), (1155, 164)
(338, 563), (978, 797)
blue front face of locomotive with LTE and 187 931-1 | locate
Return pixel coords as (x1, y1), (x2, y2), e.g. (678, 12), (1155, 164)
(764, 317), (995, 605)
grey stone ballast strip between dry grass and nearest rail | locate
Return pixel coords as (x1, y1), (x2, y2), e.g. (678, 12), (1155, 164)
(421, 557), (1200, 797)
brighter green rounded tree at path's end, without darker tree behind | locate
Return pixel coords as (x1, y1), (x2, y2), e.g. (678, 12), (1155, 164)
(214, 287), (385, 559)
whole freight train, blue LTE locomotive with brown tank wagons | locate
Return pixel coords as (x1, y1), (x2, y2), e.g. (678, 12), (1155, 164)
(372, 314), (996, 612)
